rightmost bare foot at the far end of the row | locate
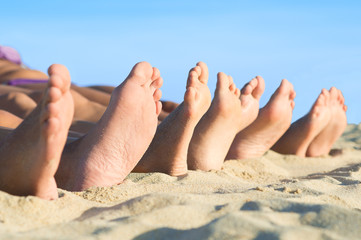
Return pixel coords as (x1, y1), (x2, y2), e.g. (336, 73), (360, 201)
(306, 87), (347, 157)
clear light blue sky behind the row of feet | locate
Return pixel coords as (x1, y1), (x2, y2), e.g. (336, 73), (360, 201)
(0, 0), (361, 123)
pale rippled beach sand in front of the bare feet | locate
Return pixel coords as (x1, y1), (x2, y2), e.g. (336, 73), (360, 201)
(0, 124), (361, 240)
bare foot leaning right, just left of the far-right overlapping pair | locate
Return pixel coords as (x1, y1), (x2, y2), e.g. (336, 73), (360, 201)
(226, 79), (296, 159)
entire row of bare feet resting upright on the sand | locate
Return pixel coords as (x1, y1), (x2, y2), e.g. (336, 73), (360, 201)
(0, 62), (347, 199)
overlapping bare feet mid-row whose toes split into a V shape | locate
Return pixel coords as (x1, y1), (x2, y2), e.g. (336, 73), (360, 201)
(188, 73), (264, 171)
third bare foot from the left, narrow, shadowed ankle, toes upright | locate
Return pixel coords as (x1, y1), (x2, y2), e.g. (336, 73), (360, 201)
(134, 62), (211, 176)
